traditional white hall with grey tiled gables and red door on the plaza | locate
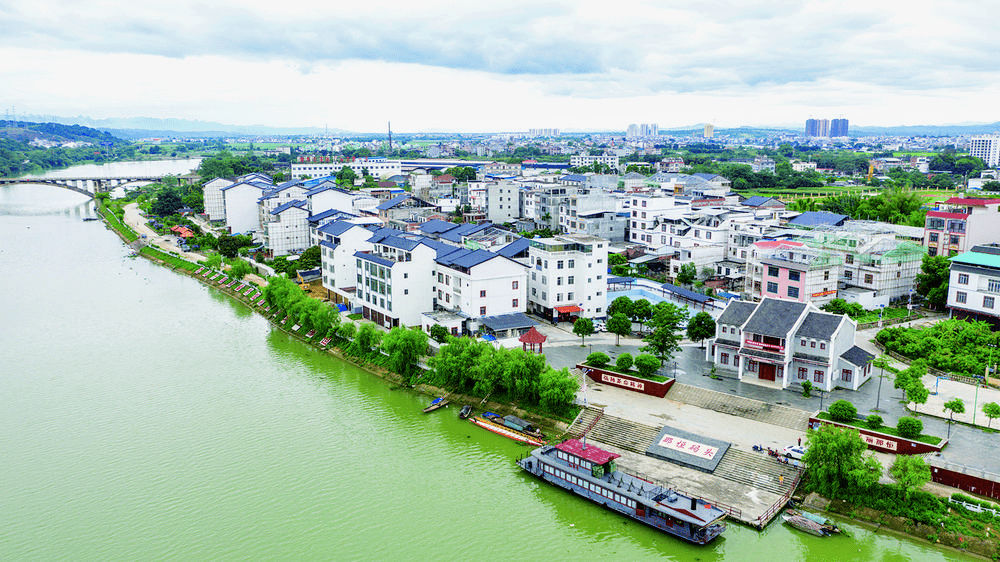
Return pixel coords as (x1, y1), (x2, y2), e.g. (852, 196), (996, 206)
(706, 298), (874, 391)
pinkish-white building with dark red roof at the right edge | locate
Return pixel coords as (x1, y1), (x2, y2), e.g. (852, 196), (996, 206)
(924, 197), (1000, 256)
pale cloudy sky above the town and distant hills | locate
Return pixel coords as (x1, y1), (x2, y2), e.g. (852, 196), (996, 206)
(0, 0), (1000, 132)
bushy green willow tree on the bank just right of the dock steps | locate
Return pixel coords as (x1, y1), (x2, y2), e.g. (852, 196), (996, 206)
(802, 425), (882, 498)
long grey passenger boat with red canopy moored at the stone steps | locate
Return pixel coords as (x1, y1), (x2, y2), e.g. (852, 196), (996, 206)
(517, 439), (726, 544)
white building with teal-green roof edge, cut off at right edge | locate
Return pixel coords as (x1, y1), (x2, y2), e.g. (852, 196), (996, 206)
(948, 244), (1000, 331)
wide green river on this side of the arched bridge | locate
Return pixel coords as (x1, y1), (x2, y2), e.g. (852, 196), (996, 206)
(0, 174), (971, 562)
